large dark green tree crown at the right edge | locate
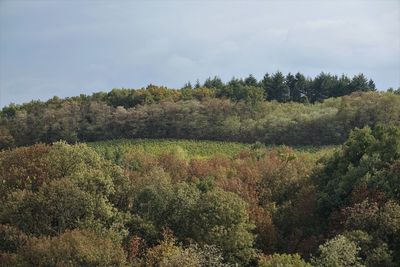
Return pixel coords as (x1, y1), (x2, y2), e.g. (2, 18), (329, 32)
(315, 126), (400, 214)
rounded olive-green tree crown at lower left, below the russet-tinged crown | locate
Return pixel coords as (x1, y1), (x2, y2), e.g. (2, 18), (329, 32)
(0, 179), (114, 235)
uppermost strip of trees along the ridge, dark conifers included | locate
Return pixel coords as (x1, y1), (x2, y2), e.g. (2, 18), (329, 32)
(4, 71), (382, 112)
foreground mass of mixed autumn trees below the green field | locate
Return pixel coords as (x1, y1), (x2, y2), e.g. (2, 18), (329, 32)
(0, 126), (400, 266)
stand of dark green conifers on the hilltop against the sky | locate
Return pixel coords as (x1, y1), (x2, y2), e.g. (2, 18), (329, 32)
(192, 71), (376, 103)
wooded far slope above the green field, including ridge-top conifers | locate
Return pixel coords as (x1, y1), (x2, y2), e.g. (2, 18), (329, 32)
(0, 72), (400, 148)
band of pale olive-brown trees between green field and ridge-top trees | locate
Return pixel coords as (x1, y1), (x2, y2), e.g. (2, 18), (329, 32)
(0, 89), (400, 148)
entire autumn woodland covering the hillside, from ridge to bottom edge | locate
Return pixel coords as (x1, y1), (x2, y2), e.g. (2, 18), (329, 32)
(0, 72), (400, 267)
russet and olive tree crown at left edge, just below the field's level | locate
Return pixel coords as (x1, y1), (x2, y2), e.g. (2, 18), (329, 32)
(0, 142), (122, 199)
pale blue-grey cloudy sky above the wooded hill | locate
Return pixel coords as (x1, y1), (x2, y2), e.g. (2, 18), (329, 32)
(0, 0), (400, 107)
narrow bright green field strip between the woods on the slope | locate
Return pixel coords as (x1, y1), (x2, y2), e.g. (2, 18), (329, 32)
(88, 139), (336, 161)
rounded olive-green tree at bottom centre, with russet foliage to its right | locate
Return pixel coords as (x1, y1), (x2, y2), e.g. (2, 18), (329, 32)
(192, 189), (255, 265)
